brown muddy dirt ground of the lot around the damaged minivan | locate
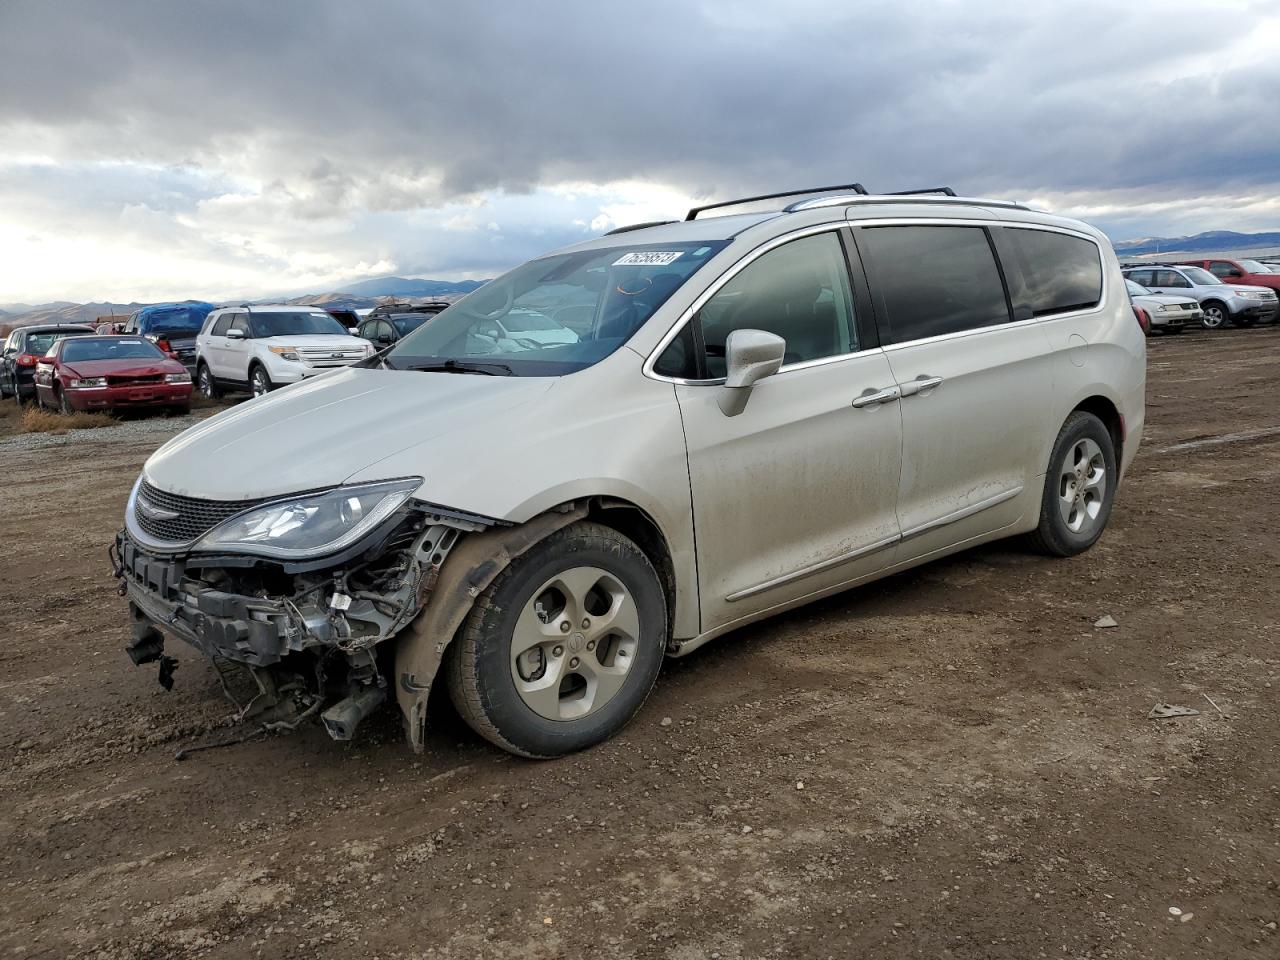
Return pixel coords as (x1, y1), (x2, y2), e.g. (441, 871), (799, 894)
(0, 328), (1280, 960)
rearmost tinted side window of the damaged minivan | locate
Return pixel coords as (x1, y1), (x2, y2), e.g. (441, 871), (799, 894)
(1005, 229), (1102, 316)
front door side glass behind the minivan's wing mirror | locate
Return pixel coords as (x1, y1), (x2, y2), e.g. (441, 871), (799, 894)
(655, 233), (858, 379)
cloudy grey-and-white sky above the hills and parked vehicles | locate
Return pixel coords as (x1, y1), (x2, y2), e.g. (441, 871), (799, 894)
(0, 0), (1280, 303)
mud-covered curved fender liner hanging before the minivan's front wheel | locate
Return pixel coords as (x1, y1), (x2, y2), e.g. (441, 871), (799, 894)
(396, 502), (588, 753)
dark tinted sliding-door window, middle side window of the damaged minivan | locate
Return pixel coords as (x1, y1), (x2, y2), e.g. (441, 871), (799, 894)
(858, 227), (1009, 343)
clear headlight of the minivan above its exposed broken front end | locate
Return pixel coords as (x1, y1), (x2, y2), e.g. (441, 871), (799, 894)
(195, 477), (422, 558)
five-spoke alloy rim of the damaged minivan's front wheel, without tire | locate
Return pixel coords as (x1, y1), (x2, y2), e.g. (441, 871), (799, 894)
(511, 567), (640, 721)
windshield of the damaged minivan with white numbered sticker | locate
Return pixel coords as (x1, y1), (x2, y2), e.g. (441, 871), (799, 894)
(384, 241), (728, 376)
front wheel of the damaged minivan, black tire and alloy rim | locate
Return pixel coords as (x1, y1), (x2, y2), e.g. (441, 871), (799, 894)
(447, 522), (667, 758)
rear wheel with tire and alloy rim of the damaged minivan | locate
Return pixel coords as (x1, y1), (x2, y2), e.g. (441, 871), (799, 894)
(1030, 410), (1120, 557)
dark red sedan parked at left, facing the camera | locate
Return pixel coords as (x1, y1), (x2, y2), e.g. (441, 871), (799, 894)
(36, 337), (191, 413)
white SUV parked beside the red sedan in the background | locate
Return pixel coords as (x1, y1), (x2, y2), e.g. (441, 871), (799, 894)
(196, 305), (375, 398)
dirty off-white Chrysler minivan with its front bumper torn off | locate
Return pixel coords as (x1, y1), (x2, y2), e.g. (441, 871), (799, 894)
(115, 188), (1146, 756)
